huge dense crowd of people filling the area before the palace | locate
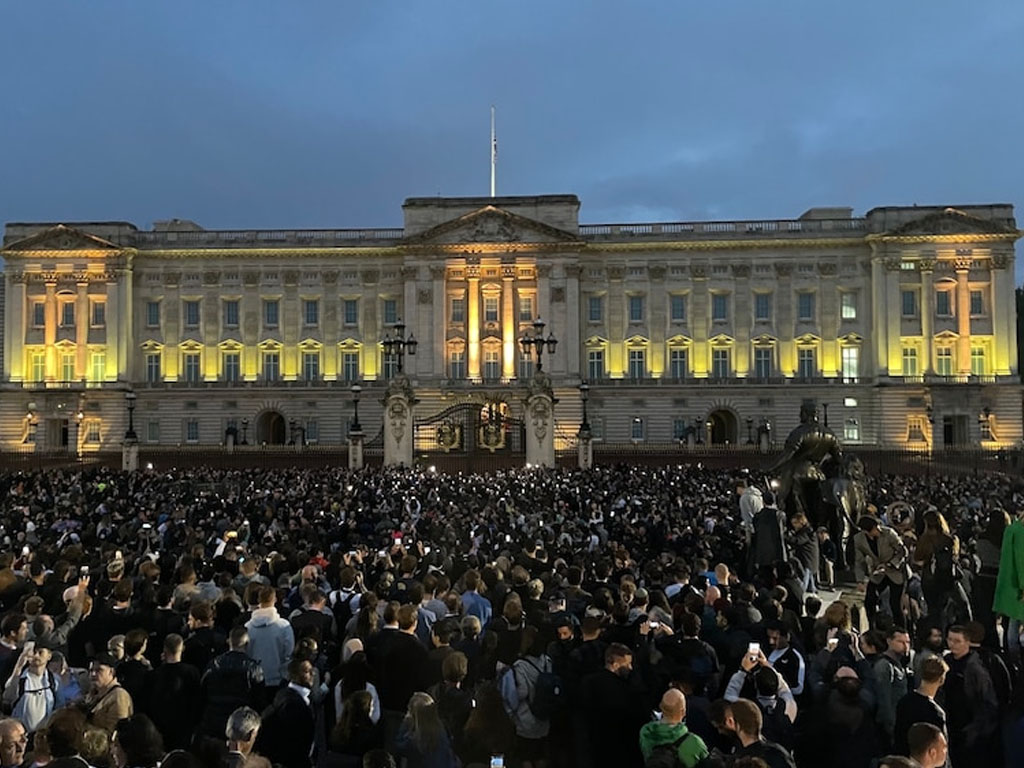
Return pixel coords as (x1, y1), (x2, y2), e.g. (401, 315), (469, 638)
(0, 466), (1024, 768)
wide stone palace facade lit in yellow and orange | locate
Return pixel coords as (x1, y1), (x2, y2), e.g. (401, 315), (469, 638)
(0, 195), (1022, 454)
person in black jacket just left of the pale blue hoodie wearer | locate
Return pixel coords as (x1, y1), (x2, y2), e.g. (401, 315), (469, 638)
(200, 627), (265, 739)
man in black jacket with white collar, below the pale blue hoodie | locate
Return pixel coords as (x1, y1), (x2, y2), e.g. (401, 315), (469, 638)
(256, 658), (315, 768)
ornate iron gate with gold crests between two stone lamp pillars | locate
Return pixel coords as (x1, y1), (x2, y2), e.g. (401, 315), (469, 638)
(414, 402), (526, 472)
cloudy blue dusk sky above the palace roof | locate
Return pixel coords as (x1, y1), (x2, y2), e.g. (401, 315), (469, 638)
(0, 0), (1024, 275)
